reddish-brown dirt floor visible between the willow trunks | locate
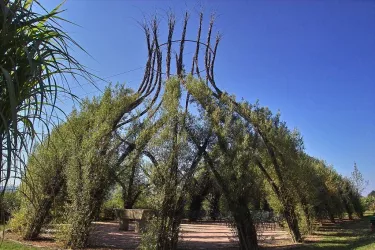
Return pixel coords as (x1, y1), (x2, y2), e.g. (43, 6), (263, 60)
(6, 222), (291, 250)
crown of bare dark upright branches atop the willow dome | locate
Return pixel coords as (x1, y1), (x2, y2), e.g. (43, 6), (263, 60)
(117, 12), (220, 128)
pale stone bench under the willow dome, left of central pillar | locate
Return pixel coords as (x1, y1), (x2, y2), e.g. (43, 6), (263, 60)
(115, 209), (154, 233)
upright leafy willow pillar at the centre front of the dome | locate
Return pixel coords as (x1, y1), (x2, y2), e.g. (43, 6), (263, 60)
(141, 78), (189, 249)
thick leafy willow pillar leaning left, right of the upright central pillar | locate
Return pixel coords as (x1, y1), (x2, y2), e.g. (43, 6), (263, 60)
(186, 78), (260, 249)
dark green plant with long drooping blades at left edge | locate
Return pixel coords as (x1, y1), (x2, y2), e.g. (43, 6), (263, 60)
(0, 0), (92, 193)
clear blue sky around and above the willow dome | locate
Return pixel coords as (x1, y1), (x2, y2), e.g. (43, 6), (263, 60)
(42, 0), (375, 193)
